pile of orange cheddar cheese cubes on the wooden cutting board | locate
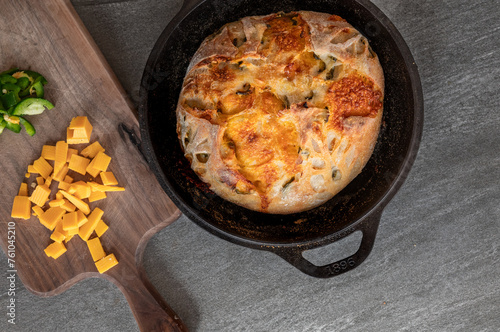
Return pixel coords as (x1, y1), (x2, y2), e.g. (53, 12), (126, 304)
(11, 116), (125, 273)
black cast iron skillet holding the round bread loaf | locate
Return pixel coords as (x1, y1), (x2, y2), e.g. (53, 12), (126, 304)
(139, 0), (423, 278)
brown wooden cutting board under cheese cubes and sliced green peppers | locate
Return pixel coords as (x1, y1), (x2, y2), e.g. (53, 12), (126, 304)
(0, 0), (185, 331)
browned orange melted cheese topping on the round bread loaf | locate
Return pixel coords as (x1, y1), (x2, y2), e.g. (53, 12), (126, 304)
(180, 13), (383, 210)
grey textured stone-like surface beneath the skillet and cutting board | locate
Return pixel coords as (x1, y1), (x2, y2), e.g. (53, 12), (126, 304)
(0, 0), (500, 332)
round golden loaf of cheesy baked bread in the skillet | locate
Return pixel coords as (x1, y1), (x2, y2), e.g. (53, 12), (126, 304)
(176, 11), (384, 214)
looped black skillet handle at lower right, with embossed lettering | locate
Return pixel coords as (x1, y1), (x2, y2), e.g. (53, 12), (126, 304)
(273, 209), (382, 278)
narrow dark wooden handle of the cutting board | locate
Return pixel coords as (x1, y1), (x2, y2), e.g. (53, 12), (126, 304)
(110, 264), (187, 332)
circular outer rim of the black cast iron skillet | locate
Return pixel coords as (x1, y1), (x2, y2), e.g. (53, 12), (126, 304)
(138, 0), (424, 249)
